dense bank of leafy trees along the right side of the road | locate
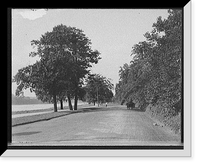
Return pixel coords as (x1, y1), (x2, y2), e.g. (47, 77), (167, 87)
(115, 10), (182, 114)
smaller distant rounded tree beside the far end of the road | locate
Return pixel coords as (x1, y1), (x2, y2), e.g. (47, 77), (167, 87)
(85, 74), (113, 106)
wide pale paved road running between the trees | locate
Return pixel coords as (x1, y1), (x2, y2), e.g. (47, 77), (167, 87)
(12, 106), (180, 146)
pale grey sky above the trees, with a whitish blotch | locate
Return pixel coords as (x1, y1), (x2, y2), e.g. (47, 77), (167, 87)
(11, 9), (168, 97)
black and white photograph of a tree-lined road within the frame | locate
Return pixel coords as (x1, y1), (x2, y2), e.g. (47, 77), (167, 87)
(2, 3), (192, 157)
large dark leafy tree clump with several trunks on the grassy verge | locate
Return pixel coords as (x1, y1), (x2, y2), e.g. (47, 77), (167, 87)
(14, 24), (101, 112)
